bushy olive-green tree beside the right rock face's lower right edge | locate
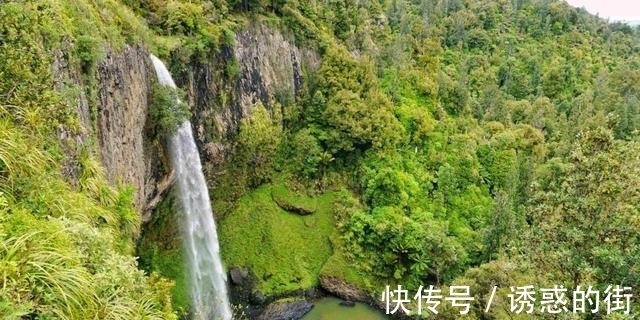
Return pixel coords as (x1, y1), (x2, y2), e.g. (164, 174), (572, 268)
(306, 49), (403, 154)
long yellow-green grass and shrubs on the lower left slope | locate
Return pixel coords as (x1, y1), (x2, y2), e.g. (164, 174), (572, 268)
(0, 119), (174, 319)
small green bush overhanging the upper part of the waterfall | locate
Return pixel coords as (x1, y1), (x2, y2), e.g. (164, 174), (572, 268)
(149, 82), (190, 137)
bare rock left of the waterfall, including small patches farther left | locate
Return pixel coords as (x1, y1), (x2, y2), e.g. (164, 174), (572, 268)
(53, 47), (172, 218)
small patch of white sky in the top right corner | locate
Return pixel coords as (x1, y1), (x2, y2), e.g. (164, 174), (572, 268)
(565, 0), (640, 21)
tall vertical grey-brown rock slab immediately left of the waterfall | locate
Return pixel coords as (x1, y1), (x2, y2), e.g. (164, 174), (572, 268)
(96, 47), (169, 215)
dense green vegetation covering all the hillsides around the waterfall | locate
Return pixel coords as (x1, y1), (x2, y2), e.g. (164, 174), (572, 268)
(0, 0), (640, 319)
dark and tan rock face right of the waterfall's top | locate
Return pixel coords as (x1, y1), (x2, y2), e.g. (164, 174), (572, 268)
(177, 22), (319, 180)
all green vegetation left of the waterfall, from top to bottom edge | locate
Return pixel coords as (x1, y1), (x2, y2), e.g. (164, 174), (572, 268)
(0, 0), (176, 319)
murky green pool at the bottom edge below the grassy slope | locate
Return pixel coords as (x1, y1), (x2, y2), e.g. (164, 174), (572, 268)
(302, 297), (389, 320)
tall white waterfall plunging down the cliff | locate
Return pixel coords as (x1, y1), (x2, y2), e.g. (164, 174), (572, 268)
(151, 55), (231, 320)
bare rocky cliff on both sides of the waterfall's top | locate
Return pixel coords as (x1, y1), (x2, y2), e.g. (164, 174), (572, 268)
(53, 23), (319, 219)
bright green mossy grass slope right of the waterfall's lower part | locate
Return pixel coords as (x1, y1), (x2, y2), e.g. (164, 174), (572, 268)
(220, 184), (335, 295)
